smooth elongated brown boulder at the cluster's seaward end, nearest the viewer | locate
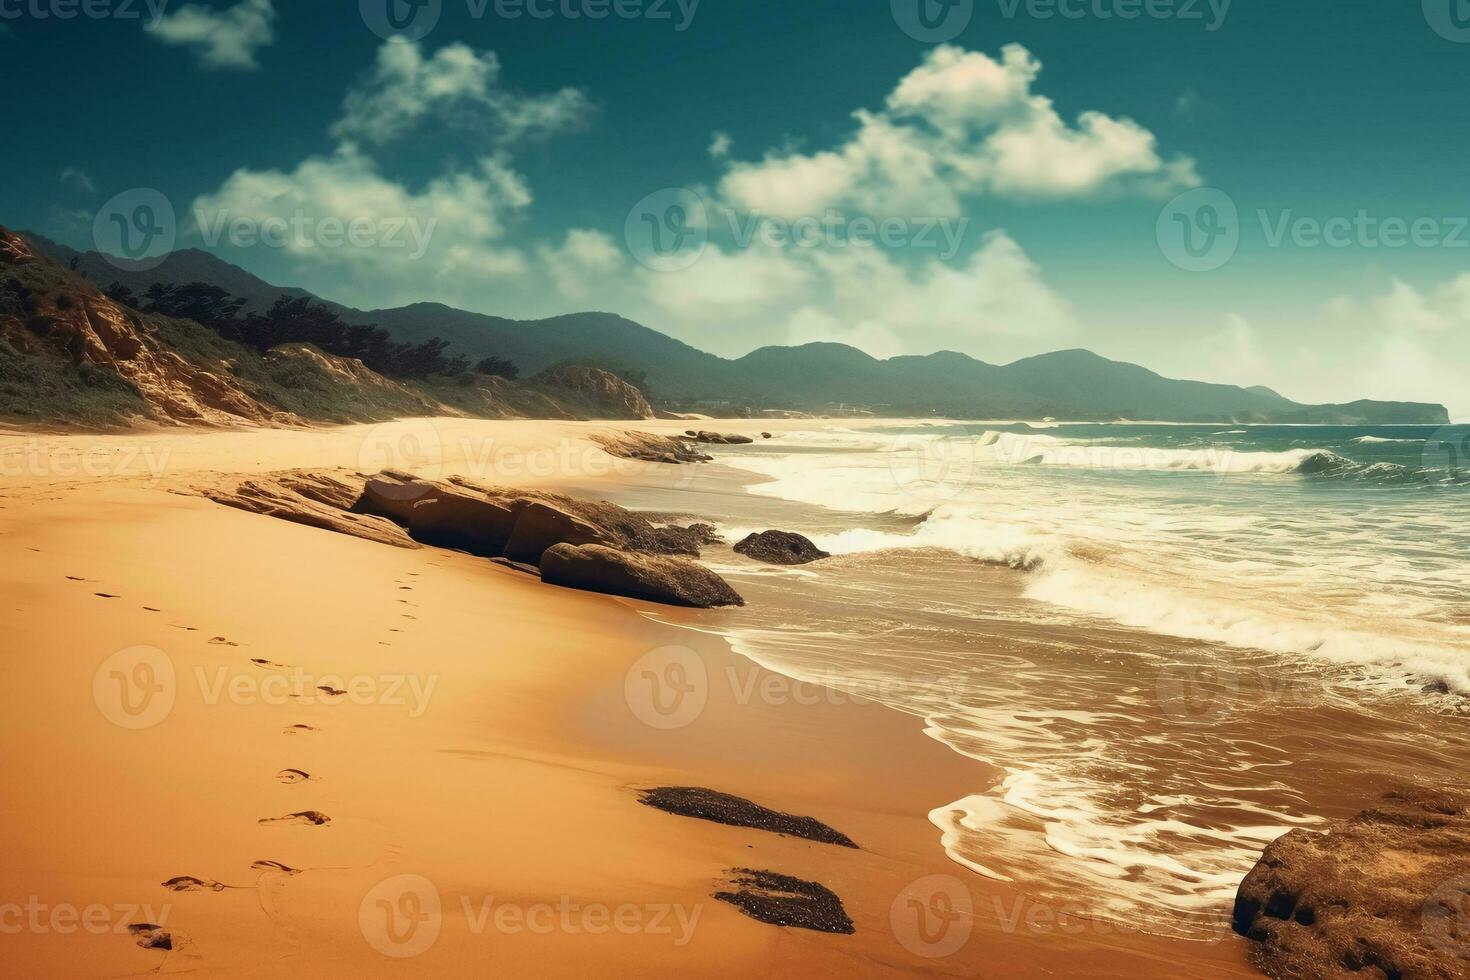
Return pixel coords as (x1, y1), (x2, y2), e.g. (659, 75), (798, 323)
(541, 544), (745, 608)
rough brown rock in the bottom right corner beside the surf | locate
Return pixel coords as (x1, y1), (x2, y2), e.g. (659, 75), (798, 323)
(1235, 788), (1470, 980)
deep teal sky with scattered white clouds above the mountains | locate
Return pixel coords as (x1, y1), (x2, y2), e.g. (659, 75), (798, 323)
(0, 0), (1470, 417)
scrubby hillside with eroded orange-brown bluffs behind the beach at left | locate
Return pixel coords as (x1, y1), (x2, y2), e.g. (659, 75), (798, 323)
(0, 228), (653, 428)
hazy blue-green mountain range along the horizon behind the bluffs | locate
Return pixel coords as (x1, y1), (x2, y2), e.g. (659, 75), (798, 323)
(28, 234), (1449, 425)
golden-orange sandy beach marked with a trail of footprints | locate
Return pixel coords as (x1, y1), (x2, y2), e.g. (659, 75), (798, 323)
(0, 420), (1258, 977)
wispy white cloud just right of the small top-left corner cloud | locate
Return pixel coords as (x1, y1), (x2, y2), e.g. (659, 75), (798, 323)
(332, 38), (591, 144)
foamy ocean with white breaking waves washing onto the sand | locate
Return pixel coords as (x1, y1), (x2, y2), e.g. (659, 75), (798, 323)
(599, 423), (1470, 939)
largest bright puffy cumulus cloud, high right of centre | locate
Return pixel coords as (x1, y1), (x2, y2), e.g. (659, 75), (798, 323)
(720, 44), (1200, 216)
